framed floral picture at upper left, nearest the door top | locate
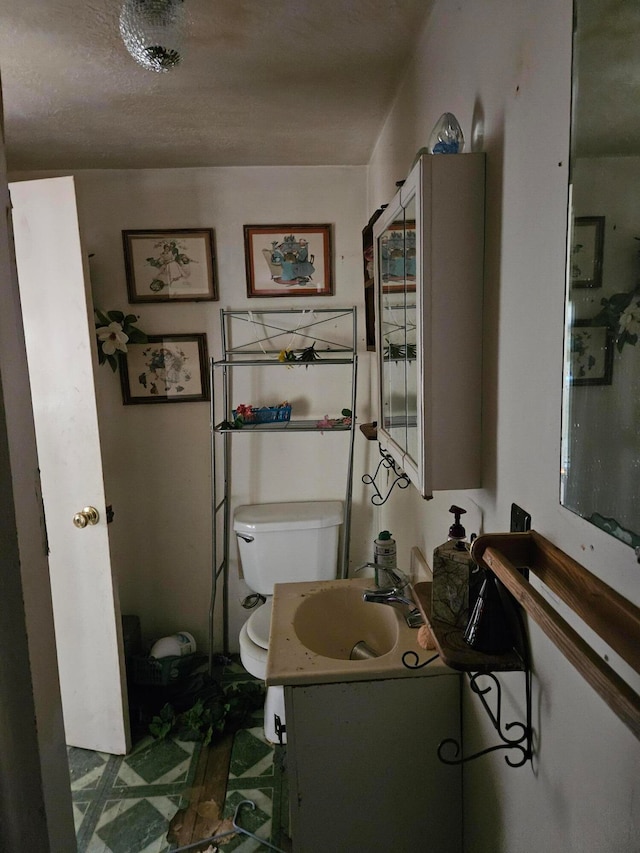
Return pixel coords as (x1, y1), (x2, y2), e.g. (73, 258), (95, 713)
(122, 228), (218, 302)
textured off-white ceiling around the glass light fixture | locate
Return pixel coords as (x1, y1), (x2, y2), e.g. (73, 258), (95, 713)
(0, 0), (431, 171)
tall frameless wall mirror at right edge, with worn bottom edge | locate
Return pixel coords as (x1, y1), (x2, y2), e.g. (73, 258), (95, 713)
(560, 0), (640, 548)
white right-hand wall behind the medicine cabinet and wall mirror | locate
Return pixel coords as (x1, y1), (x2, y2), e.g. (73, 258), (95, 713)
(369, 0), (640, 853)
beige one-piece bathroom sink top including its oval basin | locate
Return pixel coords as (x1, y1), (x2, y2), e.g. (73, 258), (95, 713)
(266, 577), (448, 686)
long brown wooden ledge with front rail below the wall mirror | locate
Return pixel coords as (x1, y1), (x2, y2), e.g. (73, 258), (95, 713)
(471, 530), (640, 738)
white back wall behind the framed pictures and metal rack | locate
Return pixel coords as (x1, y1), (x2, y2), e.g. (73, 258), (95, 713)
(12, 167), (371, 650)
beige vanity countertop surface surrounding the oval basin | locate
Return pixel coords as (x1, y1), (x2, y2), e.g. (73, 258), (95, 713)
(266, 578), (452, 686)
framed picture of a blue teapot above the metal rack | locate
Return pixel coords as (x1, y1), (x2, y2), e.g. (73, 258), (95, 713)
(244, 225), (333, 297)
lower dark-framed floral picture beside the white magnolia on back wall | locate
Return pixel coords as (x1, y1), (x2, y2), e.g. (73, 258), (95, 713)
(120, 334), (209, 406)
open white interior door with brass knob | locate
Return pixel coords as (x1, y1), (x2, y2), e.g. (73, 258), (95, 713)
(10, 177), (130, 754)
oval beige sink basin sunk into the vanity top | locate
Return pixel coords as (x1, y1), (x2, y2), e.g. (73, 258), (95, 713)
(293, 585), (399, 660)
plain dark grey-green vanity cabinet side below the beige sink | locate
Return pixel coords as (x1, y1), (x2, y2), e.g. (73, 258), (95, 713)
(285, 668), (462, 853)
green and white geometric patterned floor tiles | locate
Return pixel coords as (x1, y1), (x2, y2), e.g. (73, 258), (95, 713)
(68, 663), (288, 853)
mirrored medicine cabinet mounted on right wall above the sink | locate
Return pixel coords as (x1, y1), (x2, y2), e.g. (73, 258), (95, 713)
(373, 153), (485, 498)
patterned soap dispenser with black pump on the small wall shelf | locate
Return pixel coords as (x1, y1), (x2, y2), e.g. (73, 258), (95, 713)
(431, 505), (475, 628)
